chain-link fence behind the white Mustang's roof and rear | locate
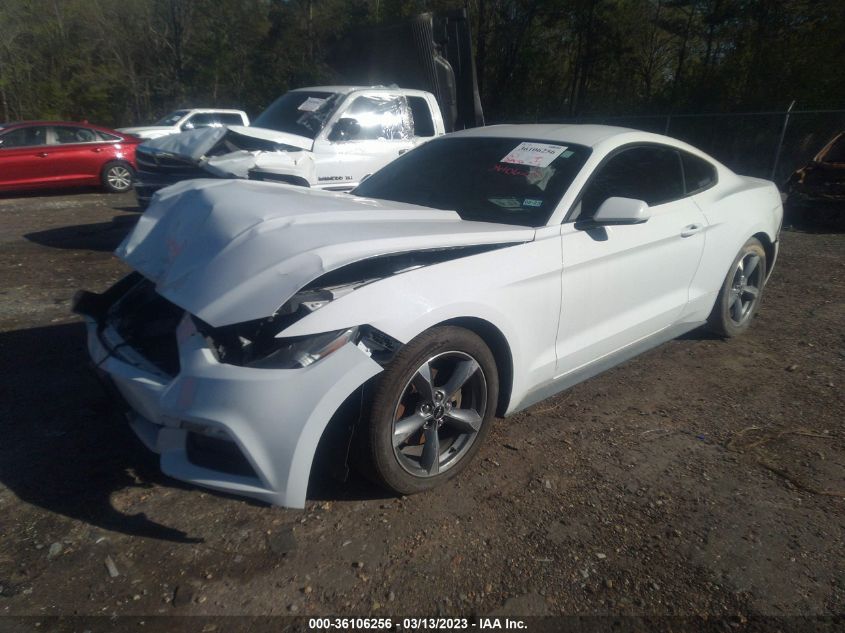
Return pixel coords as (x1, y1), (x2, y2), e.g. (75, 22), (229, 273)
(524, 110), (845, 186)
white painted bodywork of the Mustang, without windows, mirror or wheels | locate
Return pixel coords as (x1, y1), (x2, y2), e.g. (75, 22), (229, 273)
(81, 125), (782, 507)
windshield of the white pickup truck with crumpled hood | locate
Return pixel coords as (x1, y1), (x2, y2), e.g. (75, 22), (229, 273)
(252, 90), (343, 139)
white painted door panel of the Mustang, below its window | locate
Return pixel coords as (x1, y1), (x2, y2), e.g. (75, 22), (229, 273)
(557, 198), (704, 374)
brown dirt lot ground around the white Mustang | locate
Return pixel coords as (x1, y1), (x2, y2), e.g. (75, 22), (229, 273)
(0, 192), (845, 630)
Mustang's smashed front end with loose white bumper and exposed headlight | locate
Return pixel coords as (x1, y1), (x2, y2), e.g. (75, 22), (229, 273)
(74, 239), (520, 507)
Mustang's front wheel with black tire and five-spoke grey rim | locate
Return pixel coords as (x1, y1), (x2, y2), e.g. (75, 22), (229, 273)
(358, 326), (499, 494)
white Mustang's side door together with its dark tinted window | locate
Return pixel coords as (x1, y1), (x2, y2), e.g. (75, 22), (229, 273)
(557, 145), (706, 376)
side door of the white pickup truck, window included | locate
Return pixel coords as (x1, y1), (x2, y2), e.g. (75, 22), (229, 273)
(314, 92), (415, 187)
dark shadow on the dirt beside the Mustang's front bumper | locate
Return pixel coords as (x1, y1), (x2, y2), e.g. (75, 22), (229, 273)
(0, 323), (202, 543)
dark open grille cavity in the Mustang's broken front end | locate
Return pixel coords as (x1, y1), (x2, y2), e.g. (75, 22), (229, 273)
(107, 279), (185, 376)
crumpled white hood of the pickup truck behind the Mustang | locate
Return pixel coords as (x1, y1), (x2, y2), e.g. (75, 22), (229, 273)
(142, 125), (314, 161)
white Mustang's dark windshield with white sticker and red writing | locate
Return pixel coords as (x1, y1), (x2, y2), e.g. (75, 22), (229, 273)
(353, 137), (590, 227)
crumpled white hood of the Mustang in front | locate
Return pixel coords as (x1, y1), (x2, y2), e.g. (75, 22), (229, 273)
(115, 180), (534, 327)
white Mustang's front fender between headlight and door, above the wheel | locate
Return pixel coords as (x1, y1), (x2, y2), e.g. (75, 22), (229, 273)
(279, 236), (561, 412)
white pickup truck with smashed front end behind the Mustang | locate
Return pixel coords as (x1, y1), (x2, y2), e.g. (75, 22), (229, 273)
(135, 86), (445, 207)
